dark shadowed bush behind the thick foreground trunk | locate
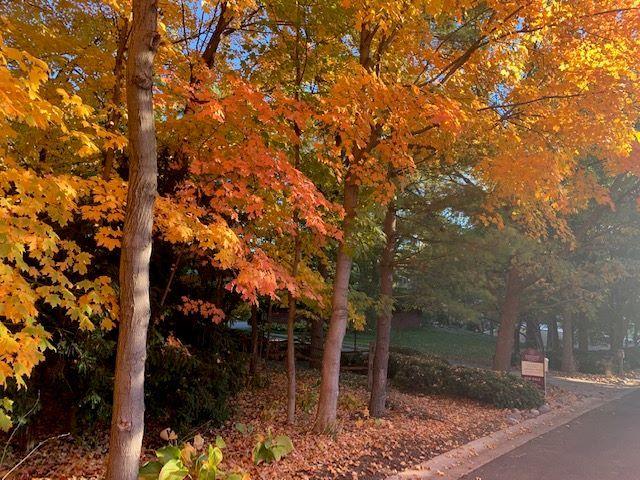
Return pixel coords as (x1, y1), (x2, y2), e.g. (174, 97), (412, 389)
(14, 326), (246, 434)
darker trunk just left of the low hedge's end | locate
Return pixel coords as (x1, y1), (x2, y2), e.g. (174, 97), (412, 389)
(369, 202), (396, 417)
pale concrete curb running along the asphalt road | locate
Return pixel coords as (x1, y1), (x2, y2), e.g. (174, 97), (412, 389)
(386, 388), (637, 480)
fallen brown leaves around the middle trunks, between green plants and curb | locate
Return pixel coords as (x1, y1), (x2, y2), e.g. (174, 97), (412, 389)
(170, 371), (505, 480)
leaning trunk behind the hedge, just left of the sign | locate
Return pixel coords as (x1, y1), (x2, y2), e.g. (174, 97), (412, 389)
(493, 264), (524, 372)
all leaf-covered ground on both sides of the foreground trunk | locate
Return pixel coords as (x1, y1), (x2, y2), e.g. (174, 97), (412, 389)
(2, 370), (576, 480)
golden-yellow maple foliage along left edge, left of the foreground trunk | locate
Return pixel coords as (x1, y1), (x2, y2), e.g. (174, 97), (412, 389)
(0, 29), (118, 429)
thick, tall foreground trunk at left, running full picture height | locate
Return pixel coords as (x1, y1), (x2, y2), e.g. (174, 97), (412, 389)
(106, 0), (160, 480)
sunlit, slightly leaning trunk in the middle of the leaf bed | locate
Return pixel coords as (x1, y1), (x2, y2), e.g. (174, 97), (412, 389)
(313, 179), (358, 432)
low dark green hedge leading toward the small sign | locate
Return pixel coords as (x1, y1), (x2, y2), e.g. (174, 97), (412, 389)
(389, 352), (544, 408)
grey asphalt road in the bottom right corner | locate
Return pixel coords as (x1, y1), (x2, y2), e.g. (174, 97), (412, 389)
(461, 391), (640, 480)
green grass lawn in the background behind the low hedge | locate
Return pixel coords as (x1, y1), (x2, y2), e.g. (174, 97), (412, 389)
(344, 327), (496, 365)
